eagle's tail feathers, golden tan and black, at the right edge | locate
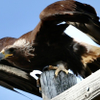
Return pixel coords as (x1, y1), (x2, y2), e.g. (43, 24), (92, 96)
(73, 42), (100, 76)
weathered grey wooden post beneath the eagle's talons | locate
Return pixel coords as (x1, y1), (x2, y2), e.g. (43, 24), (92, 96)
(40, 70), (77, 100)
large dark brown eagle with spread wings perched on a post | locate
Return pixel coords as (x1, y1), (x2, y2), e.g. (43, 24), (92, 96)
(0, 0), (100, 96)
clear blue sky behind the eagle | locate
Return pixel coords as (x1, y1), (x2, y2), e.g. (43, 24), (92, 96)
(0, 0), (100, 100)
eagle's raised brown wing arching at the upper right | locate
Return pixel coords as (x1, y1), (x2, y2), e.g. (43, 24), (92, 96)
(40, 0), (100, 44)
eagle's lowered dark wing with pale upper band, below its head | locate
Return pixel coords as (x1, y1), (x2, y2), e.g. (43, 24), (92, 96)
(0, 64), (41, 97)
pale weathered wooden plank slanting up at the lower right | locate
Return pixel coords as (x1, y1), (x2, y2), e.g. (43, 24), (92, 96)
(51, 70), (100, 100)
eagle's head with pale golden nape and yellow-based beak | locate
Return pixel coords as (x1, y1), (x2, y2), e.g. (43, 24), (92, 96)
(0, 40), (35, 70)
